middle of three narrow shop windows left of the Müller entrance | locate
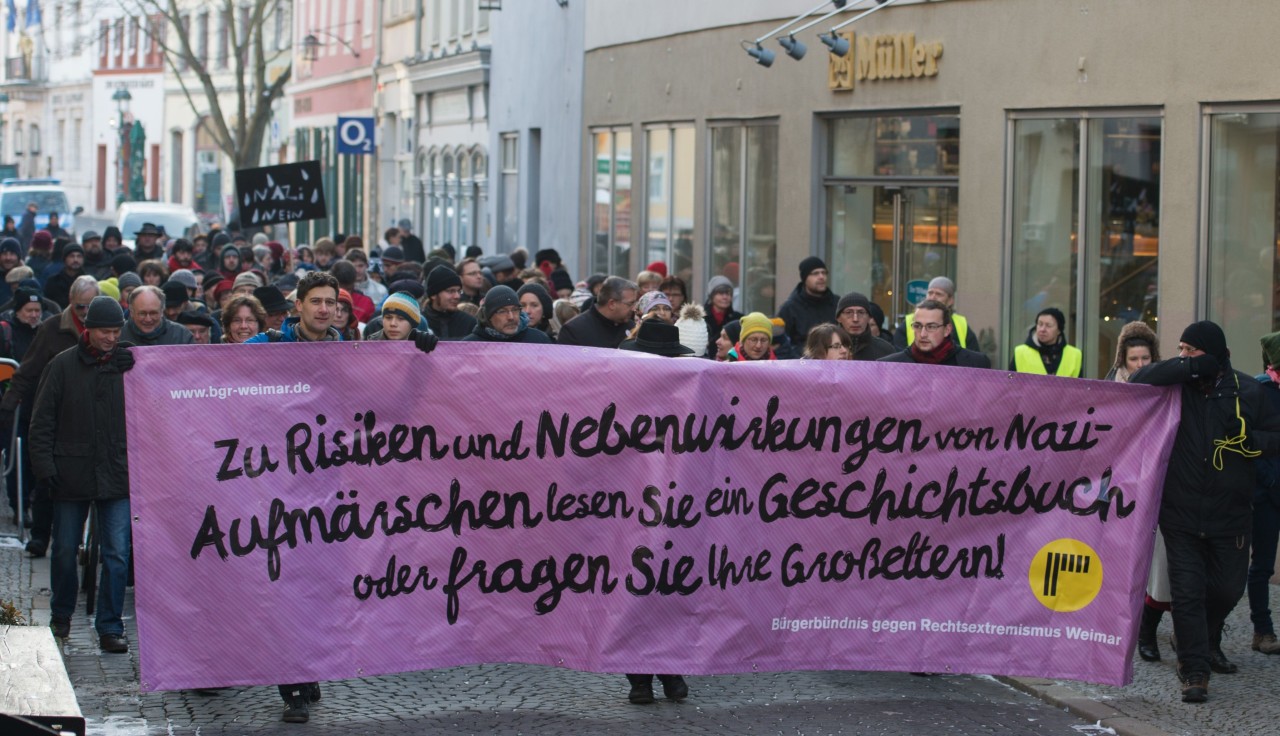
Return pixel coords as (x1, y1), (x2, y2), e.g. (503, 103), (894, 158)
(644, 125), (695, 285)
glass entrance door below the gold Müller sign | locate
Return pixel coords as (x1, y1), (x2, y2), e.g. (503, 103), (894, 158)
(826, 183), (960, 325)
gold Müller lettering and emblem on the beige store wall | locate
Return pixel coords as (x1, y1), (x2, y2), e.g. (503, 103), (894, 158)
(827, 31), (942, 91)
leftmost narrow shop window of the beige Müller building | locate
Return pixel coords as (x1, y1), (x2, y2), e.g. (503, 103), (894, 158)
(590, 129), (634, 278)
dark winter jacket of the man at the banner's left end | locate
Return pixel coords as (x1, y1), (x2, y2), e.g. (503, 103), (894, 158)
(29, 343), (129, 500)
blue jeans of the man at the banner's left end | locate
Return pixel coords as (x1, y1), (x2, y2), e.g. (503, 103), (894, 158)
(49, 498), (131, 635)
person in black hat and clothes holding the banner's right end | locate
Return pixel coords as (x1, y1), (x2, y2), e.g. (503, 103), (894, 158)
(1129, 321), (1280, 703)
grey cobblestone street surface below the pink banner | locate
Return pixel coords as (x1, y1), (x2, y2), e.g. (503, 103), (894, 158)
(0, 513), (1280, 736)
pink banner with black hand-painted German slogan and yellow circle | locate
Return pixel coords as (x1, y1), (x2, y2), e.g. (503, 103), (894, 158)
(125, 343), (1178, 690)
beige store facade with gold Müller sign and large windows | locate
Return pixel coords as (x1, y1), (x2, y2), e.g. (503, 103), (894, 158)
(577, 0), (1280, 376)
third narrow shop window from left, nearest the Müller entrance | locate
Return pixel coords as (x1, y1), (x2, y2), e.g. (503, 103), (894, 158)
(701, 123), (780, 314)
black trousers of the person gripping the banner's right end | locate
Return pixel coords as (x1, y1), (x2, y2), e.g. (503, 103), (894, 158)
(1161, 527), (1249, 676)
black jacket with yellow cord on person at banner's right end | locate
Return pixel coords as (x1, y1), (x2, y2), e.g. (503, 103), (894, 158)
(1129, 357), (1280, 536)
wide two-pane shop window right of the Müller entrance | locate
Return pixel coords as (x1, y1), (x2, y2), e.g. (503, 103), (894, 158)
(1002, 113), (1162, 378)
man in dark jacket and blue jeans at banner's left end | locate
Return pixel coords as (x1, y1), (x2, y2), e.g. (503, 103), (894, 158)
(31, 297), (133, 653)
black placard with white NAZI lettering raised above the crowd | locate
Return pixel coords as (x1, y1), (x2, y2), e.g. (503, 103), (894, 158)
(236, 161), (326, 225)
